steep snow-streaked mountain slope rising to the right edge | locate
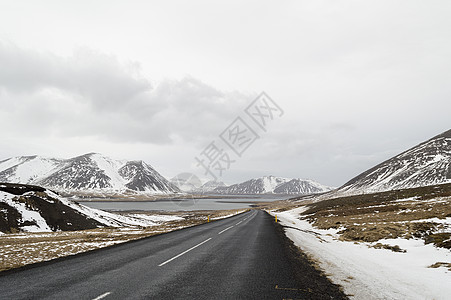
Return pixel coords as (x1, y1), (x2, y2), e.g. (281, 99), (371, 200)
(337, 130), (451, 194)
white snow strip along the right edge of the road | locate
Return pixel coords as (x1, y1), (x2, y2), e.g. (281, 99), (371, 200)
(271, 207), (451, 299)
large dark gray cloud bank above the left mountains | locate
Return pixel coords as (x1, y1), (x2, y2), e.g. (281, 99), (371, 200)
(0, 43), (251, 144)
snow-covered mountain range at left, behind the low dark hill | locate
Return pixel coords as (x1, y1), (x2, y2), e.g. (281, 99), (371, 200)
(0, 153), (179, 193)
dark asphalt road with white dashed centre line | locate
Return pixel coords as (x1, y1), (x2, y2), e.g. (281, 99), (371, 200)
(0, 211), (343, 299)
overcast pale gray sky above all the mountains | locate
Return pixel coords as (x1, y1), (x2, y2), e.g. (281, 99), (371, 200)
(0, 0), (451, 186)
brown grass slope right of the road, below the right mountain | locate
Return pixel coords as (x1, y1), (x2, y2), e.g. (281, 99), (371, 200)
(261, 184), (451, 251)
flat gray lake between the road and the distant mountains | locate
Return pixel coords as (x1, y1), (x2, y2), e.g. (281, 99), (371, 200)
(78, 195), (293, 211)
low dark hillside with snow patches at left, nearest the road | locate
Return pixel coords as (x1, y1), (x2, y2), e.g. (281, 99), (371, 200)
(0, 183), (158, 233)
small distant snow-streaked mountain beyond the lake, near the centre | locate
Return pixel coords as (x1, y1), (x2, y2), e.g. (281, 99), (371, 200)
(214, 176), (330, 194)
